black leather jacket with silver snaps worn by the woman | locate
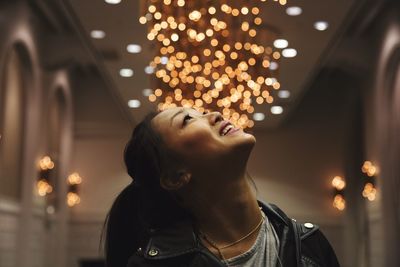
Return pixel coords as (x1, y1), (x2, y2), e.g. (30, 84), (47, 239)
(128, 202), (339, 267)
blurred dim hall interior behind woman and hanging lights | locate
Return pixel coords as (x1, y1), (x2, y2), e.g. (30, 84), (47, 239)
(0, 0), (400, 267)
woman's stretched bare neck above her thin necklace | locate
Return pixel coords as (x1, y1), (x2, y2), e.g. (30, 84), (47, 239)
(190, 177), (262, 249)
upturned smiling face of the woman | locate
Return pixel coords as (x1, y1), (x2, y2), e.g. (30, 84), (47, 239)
(152, 107), (256, 170)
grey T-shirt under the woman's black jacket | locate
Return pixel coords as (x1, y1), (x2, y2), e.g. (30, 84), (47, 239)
(224, 214), (280, 267)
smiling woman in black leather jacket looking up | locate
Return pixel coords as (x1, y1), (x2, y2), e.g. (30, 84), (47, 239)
(101, 107), (339, 267)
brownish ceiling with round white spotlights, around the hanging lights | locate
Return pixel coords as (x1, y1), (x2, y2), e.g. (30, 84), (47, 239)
(69, 0), (360, 129)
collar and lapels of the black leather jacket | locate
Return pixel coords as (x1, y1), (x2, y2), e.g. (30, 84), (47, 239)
(143, 201), (290, 259)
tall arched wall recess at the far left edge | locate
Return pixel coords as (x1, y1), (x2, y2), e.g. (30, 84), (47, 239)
(0, 45), (27, 201)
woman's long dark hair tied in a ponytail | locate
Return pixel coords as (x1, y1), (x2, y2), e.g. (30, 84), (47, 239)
(100, 112), (190, 267)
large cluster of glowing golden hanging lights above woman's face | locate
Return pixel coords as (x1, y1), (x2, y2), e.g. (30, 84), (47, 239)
(139, 0), (286, 128)
